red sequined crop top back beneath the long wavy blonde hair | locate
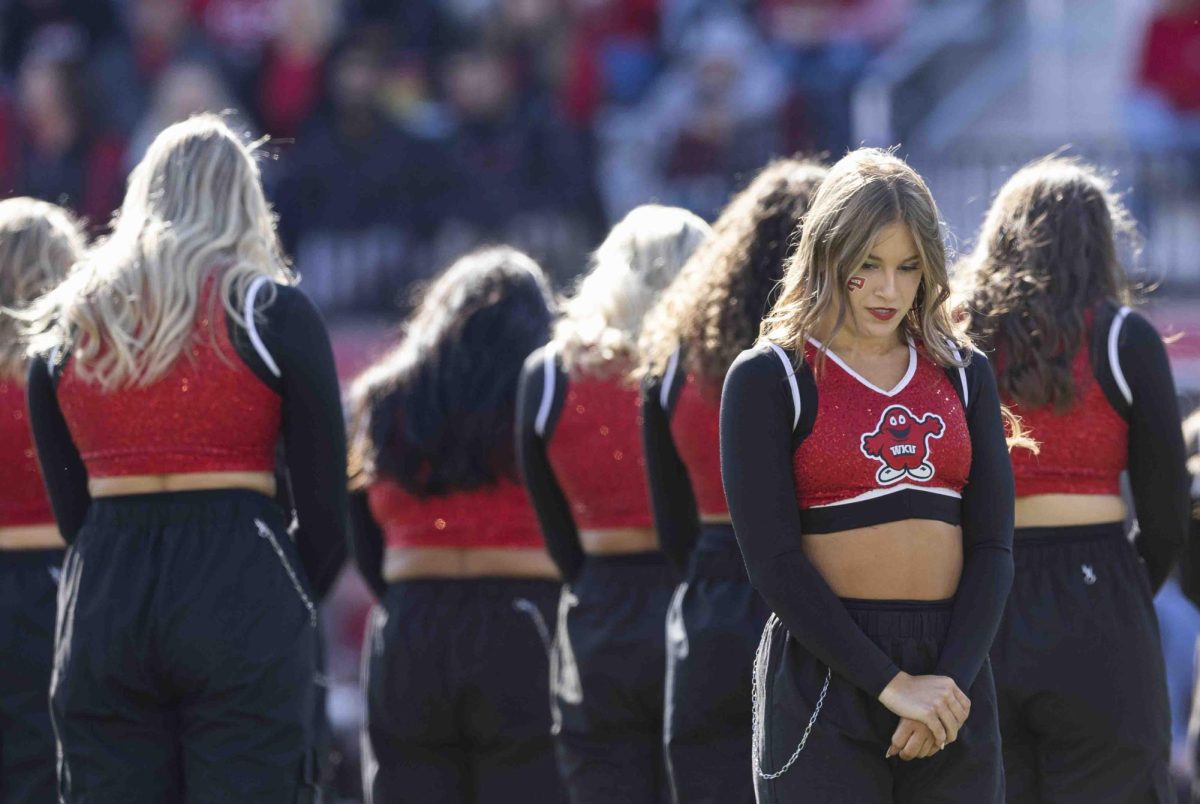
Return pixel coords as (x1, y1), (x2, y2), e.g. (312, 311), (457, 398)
(58, 281), (281, 478)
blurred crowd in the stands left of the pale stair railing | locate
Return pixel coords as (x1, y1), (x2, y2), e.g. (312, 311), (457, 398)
(0, 0), (916, 316)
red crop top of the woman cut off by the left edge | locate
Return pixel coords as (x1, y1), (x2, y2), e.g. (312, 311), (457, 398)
(0, 379), (54, 528)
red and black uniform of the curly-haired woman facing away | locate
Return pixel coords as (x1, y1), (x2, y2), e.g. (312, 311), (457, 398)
(642, 352), (770, 804)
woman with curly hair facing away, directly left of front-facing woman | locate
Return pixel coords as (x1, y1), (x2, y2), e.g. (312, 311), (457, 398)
(638, 160), (826, 804)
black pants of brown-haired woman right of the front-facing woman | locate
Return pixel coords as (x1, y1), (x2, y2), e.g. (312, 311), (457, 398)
(991, 523), (1174, 804)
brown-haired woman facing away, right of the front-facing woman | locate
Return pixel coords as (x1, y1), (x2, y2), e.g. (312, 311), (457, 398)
(961, 157), (1188, 803)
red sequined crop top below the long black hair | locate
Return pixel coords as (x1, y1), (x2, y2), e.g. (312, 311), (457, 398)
(367, 479), (544, 548)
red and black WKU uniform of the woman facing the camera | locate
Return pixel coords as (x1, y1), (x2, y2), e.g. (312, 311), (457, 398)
(721, 342), (1013, 804)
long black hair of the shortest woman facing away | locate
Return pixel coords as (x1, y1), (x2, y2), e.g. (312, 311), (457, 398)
(349, 246), (553, 496)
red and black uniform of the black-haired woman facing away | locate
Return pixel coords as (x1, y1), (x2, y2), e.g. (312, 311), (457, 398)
(350, 478), (563, 804)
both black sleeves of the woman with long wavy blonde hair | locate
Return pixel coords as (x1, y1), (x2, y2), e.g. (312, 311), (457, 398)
(26, 286), (347, 596)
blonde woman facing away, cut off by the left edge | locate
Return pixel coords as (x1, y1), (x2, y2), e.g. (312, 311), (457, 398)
(0, 198), (86, 804)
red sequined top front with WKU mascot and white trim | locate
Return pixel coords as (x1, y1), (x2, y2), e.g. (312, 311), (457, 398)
(794, 344), (971, 509)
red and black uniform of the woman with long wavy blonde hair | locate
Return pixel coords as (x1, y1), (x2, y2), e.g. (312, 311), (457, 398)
(28, 280), (346, 803)
